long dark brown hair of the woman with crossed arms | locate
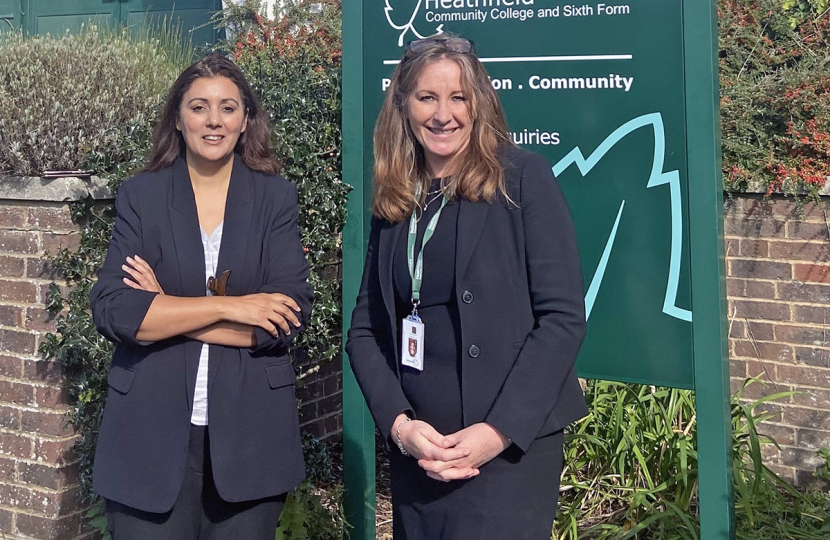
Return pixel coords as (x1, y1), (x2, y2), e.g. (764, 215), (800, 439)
(144, 53), (279, 174)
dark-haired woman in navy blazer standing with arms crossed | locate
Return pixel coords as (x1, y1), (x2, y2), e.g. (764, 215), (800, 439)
(90, 54), (312, 540)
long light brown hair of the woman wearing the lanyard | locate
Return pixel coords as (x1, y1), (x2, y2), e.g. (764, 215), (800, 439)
(372, 34), (513, 222)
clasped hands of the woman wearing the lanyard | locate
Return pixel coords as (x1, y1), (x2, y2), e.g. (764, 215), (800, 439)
(392, 414), (510, 482)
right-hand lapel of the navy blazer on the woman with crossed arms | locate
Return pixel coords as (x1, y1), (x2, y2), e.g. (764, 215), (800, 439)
(208, 155), (253, 390)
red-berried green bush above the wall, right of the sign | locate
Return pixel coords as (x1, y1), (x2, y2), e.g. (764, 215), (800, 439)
(718, 0), (830, 198)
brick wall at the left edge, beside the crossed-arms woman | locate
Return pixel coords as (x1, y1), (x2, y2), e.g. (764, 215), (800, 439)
(0, 200), (90, 539)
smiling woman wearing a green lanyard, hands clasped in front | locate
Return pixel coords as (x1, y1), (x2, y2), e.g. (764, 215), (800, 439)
(346, 35), (587, 540)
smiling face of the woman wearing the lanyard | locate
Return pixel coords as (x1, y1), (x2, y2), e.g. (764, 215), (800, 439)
(408, 58), (473, 178)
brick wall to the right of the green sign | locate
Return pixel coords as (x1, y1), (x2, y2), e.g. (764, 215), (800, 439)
(724, 196), (830, 484)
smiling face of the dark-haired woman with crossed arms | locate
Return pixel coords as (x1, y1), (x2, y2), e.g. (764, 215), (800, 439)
(176, 76), (248, 168)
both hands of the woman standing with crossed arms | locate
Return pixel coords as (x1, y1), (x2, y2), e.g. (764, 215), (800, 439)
(121, 255), (300, 337)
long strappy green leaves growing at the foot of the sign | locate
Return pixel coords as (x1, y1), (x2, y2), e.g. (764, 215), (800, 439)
(554, 380), (830, 540)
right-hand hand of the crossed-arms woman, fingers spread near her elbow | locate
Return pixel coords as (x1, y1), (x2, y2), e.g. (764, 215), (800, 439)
(224, 293), (300, 337)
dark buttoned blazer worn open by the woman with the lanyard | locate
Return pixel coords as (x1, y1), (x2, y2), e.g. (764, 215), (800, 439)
(346, 147), (587, 451)
